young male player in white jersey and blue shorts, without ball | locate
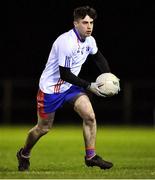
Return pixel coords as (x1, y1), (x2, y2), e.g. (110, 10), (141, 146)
(17, 6), (113, 171)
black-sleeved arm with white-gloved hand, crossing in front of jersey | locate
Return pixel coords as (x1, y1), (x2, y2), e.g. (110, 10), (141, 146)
(59, 66), (103, 96)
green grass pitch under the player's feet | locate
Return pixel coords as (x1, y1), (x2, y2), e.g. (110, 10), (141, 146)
(0, 125), (155, 179)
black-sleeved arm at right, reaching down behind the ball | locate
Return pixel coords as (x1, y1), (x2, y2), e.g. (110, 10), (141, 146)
(92, 50), (110, 73)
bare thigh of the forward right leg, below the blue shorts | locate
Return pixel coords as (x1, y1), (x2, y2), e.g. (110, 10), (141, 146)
(74, 95), (95, 120)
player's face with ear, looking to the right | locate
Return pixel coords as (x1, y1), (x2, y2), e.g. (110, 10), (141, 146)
(74, 15), (94, 39)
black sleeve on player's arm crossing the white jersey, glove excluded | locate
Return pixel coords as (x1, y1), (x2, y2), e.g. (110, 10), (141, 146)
(59, 66), (90, 89)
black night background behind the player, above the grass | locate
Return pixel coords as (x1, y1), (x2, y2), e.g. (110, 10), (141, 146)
(0, 0), (155, 125)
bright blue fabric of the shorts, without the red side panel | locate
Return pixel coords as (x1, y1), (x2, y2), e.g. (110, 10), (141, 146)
(39, 85), (85, 113)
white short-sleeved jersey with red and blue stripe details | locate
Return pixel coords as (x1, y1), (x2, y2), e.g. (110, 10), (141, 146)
(39, 29), (97, 94)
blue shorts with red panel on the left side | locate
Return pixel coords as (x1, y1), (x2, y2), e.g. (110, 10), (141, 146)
(37, 85), (85, 116)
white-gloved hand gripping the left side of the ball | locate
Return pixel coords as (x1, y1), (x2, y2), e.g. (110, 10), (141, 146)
(87, 82), (106, 97)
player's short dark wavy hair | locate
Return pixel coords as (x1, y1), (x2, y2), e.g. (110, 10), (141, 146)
(73, 6), (97, 21)
